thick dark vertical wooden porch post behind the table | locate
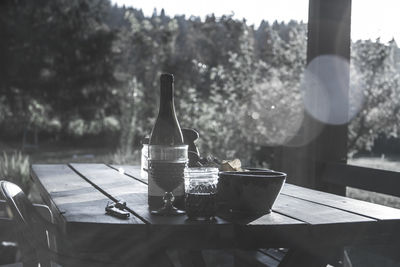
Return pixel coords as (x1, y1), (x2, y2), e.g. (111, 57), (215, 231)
(278, 0), (351, 194)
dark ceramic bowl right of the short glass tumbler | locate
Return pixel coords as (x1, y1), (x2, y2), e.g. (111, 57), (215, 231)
(217, 170), (286, 215)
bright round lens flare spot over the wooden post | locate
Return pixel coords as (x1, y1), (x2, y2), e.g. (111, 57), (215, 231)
(301, 55), (363, 125)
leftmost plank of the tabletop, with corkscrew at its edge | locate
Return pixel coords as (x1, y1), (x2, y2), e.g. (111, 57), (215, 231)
(31, 165), (143, 228)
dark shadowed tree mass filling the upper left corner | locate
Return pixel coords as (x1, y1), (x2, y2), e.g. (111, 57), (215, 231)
(0, 0), (114, 136)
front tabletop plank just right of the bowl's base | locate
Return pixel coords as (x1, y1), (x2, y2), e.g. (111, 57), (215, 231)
(272, 194), (375, 225)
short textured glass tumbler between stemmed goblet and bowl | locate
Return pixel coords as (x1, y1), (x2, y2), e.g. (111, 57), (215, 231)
(185, 167), (218, 220)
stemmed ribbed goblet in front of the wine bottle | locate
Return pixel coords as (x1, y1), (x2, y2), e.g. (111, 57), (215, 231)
(148, 145), (188, 216)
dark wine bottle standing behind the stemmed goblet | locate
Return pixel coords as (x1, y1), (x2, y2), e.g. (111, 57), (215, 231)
(148, 74), (184, 210)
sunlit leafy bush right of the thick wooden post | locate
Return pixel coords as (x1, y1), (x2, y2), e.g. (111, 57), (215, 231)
(349, 39), (400, 155)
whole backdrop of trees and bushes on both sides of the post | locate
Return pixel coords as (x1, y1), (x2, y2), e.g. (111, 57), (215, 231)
(0, 0), (400, 171)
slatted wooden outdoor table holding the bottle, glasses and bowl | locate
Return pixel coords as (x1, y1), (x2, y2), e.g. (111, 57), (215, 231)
(31, 164), (400, 266)
